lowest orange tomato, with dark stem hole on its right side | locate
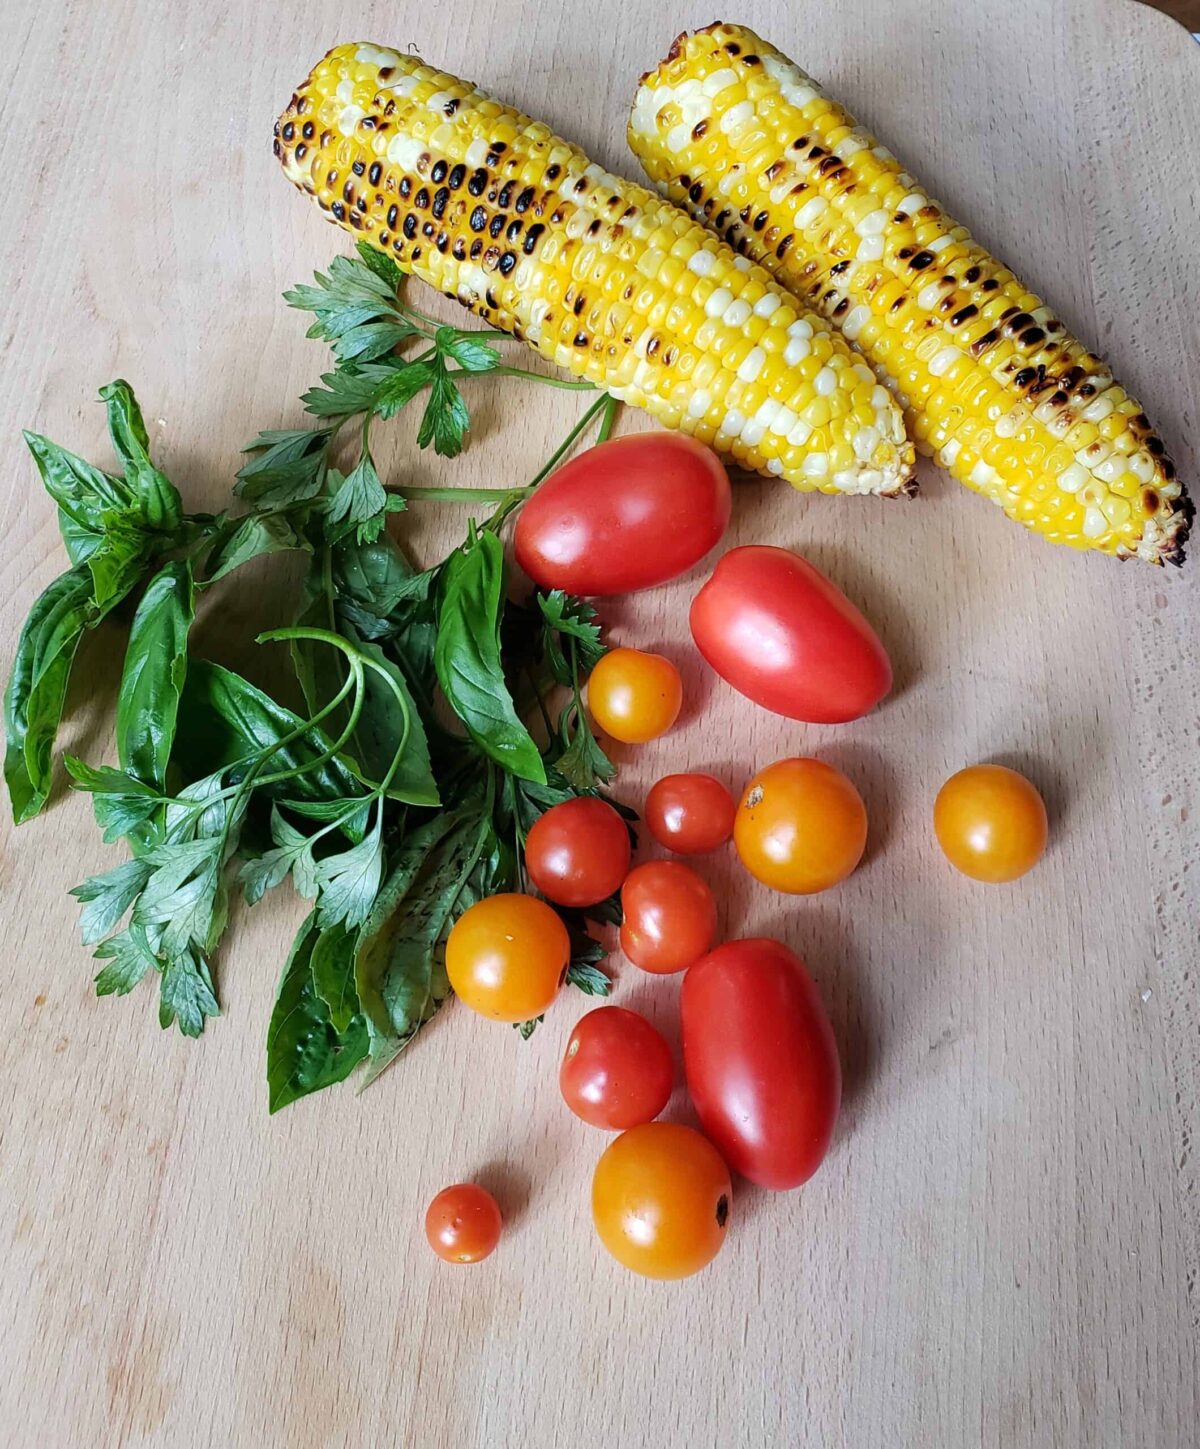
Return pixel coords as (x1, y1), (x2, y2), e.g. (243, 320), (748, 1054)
(591, 1122), (732, 1278)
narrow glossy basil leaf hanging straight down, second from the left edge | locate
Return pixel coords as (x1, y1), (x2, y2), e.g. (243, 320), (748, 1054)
(117, 561), (196, 794)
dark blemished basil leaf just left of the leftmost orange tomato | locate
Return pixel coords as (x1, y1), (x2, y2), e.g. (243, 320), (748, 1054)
(354, 814), (491, 1085)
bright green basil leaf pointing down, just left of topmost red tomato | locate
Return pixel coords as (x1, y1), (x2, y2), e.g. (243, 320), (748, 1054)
(433, 533), (546, 784)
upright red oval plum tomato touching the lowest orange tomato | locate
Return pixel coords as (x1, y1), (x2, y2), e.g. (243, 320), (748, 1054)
(680, 939), (842, 1188)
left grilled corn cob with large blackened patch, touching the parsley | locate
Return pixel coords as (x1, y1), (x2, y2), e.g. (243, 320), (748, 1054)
(275, 45), (913, 494)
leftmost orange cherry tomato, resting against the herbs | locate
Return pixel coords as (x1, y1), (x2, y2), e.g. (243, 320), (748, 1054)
(446, 894), (571, 1022)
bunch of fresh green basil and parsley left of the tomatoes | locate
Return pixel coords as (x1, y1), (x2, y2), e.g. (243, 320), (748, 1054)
(4, 246), (628, 1111)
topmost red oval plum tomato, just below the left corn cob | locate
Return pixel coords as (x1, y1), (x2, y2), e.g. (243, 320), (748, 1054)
(514, 433), (732, 594)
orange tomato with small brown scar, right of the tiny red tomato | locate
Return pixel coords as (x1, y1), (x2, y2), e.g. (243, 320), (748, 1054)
(733, 759), (867, 895)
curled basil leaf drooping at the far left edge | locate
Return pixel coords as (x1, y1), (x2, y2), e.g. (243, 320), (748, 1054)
(4, 564), (97, 824)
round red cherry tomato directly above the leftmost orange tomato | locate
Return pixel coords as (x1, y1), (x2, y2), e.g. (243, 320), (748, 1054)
(525, 796), (629, 906)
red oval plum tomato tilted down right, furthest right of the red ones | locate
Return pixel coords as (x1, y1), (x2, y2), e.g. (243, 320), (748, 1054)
(691, 545), (891, 725)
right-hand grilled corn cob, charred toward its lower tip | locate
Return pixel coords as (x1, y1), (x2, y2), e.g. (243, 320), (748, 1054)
(629, 25), (1191, 564)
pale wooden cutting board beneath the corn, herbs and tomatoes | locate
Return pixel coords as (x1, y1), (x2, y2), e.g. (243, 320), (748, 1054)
(0, 0), (1200, 1449)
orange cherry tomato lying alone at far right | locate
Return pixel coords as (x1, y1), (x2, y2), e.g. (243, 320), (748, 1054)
(933, 765), (1046, 881)
